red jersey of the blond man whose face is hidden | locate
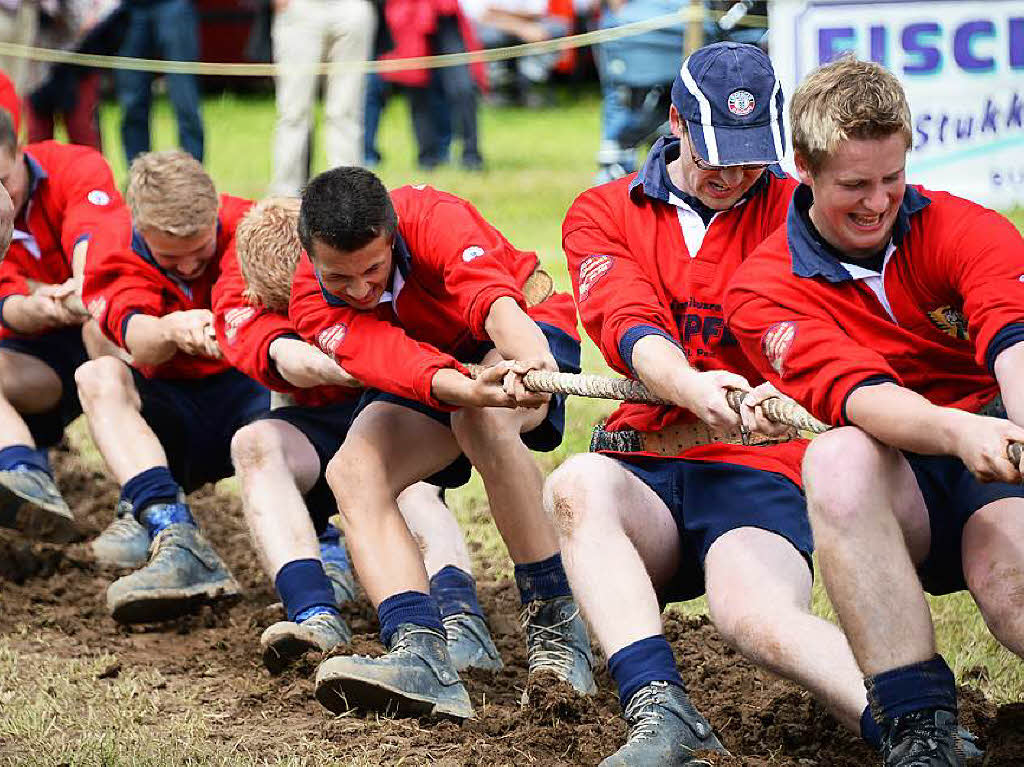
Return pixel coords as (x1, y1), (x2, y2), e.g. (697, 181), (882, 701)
(213, 242), (362, 408)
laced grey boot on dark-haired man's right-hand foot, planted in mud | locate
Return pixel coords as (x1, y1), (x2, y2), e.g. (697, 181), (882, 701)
(519, 596), (597, 695)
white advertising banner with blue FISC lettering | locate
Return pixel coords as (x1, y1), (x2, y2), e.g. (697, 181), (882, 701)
(769, 0), (1024, 210)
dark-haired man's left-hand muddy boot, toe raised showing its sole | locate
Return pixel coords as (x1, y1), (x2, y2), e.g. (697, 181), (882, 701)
(316, 624), (473, 720)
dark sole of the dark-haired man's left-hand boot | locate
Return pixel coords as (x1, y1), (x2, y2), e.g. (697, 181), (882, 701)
(315, 667), (476, 722)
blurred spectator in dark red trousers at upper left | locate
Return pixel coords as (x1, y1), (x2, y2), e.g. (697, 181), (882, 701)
(28, 0), (125, 151)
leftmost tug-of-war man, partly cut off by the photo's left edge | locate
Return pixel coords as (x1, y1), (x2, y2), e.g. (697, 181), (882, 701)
(0, 110), (125, 541)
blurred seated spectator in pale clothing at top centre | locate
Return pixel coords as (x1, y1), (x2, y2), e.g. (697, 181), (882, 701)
(462, 0), (570, 106)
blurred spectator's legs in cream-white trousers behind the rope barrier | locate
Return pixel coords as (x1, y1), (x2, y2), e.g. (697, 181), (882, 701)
(270, 0), (379, 196)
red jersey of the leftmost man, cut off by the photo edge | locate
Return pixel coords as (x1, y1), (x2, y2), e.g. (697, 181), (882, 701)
(0, 141), (124, 338)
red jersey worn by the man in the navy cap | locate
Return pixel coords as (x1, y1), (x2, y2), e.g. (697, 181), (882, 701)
(562, 139), (806, 484)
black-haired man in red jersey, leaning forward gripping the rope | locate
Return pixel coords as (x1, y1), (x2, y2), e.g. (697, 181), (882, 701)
(290, 168), (594, 718)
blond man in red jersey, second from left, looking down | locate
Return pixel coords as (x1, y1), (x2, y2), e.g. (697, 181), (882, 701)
(75, 151), (269, 623)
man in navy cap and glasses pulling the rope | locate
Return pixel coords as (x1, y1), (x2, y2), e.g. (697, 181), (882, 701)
(545, 43), (892, 765)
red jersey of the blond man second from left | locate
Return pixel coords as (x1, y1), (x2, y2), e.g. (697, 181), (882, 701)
(82, 195), (252, 378)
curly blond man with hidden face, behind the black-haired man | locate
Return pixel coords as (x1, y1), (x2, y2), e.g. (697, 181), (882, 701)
(214, 198), (502, 672)
